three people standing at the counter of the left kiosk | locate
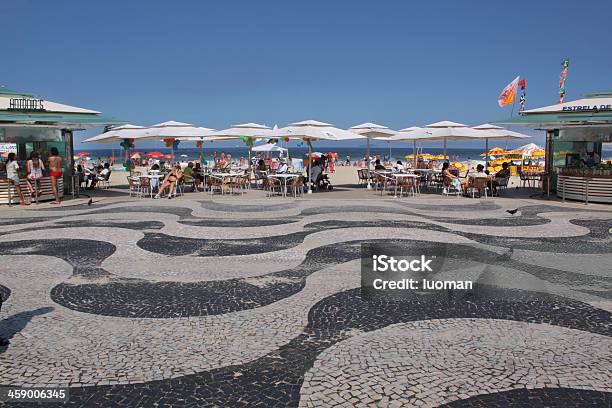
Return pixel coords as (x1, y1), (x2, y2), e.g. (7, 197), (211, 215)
(6, 147), (63, 205)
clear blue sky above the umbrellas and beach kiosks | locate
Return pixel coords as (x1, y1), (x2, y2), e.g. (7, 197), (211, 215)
(0, 0), (612, 149)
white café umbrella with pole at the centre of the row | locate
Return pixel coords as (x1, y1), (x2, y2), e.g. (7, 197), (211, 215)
(274, 120), (365, 194)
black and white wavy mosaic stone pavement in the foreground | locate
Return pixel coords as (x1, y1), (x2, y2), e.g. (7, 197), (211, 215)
(0, 196), (612, 407)
